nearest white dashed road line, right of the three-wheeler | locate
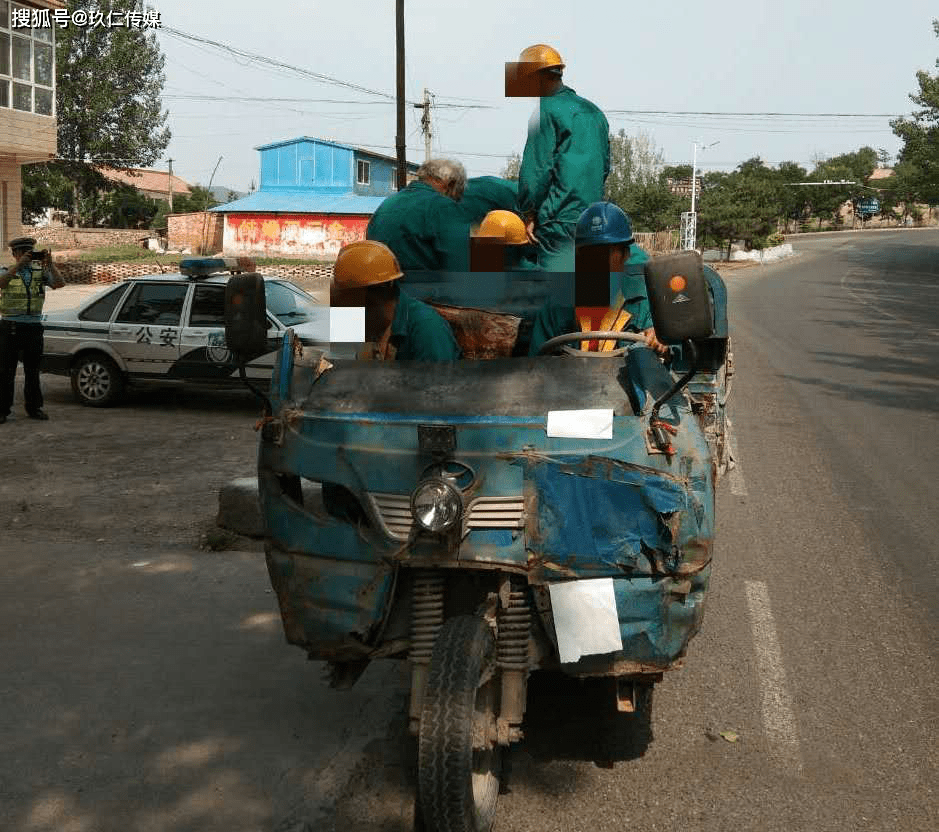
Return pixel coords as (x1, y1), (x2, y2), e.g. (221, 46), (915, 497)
(744, 581), (802, 774)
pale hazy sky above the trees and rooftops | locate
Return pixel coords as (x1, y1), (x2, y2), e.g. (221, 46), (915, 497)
(152, 0), (939, 190)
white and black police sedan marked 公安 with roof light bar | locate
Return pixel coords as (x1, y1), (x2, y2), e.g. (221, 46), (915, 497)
(42, 258), (329, 407)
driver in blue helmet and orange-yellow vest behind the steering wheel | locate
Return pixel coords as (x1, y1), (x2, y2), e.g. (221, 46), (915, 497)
(528, 202), (668, 356)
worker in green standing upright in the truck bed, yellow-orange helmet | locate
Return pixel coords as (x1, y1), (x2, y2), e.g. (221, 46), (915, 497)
(516, 44), (610, 272)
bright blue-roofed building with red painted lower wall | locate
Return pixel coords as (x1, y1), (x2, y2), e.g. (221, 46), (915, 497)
(212, 136), (418, 258)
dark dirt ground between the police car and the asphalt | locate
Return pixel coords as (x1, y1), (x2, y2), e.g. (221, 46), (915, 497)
(0, 372), (260, 549)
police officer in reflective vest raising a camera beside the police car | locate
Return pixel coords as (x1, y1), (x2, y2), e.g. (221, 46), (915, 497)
(0, 237), (65, 424)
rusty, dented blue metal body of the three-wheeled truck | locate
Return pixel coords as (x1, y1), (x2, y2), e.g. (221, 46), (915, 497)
(258, 264), (728, 745)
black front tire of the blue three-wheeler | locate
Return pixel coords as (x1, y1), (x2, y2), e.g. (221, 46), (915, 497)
(417, 615), (502, 832)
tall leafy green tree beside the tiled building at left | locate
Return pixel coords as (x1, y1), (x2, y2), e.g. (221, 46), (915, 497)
(23, 0), (170, 222)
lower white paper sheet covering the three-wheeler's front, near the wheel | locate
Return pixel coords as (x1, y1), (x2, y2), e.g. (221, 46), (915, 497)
(548, 578), (623, 663)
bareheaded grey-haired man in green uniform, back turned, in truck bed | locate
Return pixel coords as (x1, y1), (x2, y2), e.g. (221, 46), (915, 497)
(365, 159), (469, 272)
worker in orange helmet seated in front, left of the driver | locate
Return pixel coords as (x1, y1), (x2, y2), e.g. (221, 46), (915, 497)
(331, 240), (461, 361)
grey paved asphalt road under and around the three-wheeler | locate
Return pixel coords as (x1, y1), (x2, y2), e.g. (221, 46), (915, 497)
(0, 232), (939, 832)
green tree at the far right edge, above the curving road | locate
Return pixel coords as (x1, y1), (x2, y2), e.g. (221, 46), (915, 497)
(890, 19), (939, 205)
